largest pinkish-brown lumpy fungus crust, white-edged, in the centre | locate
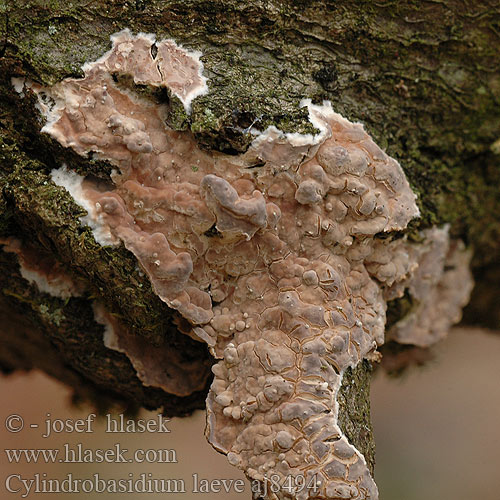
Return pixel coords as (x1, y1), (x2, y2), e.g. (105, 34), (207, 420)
(18, 31), (472, 500)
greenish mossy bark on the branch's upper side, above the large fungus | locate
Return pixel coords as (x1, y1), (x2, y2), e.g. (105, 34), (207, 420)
(0, 0), (500, 265)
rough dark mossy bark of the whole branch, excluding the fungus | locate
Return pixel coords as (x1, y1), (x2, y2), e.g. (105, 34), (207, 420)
(0, 0), (500, 482)
